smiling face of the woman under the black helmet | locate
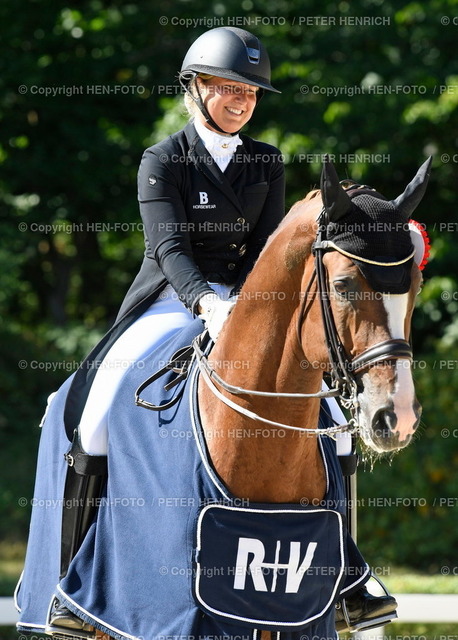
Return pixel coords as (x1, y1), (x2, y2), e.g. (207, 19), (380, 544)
(197, 77), (258, 133)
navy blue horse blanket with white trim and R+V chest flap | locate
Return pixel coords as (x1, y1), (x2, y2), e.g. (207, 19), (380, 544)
(16, 321), (369, 640)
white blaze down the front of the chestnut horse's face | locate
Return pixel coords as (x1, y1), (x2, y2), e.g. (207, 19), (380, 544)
(383, 293), (417, 442)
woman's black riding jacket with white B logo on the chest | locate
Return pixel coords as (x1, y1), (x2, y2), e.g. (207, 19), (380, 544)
(118, 124), (285, 318)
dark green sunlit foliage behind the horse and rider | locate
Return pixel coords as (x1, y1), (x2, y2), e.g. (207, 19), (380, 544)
(0, 0), (458, 573)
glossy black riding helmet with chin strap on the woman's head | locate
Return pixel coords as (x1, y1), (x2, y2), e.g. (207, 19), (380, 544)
(179, 27), (280, 135)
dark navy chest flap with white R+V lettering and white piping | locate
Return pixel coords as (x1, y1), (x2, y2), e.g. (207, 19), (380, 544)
(194, 504), (346, 631)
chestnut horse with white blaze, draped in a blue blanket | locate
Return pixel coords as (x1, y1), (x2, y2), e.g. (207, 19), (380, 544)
(199, 155), (430, 510)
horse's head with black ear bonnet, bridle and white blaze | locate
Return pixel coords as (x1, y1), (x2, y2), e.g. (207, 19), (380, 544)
(302, 159), (431, 453)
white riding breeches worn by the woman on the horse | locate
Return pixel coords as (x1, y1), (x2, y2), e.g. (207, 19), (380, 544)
(79, 284), (351, 455)
